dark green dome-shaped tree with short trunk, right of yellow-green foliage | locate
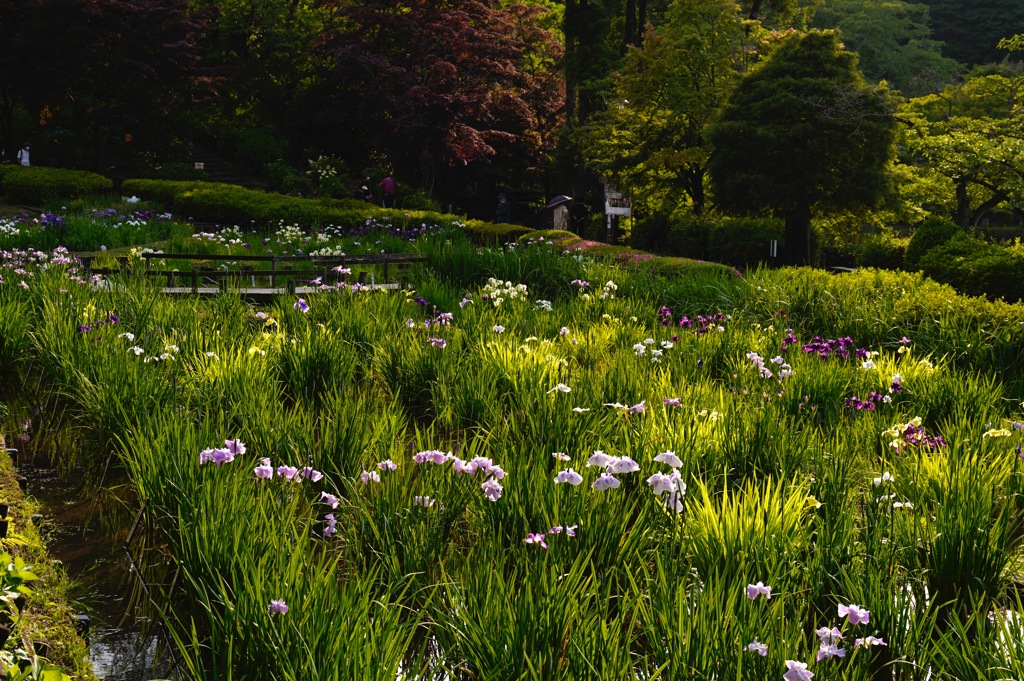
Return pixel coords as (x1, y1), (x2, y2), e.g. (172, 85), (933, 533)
(709, 31), (895, 264)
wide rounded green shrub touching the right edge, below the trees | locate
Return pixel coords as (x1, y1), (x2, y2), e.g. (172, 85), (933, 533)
(921, 232), (1024, 302)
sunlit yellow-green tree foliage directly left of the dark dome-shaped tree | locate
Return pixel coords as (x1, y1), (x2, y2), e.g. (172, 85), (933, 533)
(585, 0), (765, 218)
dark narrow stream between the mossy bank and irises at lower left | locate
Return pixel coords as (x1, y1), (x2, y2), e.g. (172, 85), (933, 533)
(18, 450), (176, 681)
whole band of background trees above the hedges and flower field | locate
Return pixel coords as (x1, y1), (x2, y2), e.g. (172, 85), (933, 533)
(0, 0), (1024, 263)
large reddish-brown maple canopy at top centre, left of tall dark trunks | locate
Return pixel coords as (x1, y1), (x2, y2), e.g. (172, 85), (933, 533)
(321, 0), (562, 191)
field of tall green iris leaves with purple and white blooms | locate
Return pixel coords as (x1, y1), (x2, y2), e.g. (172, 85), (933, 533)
(6, 209), (1024, 681)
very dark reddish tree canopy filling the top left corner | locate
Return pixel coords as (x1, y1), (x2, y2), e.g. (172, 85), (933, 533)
(0, 0), (204, 165)
